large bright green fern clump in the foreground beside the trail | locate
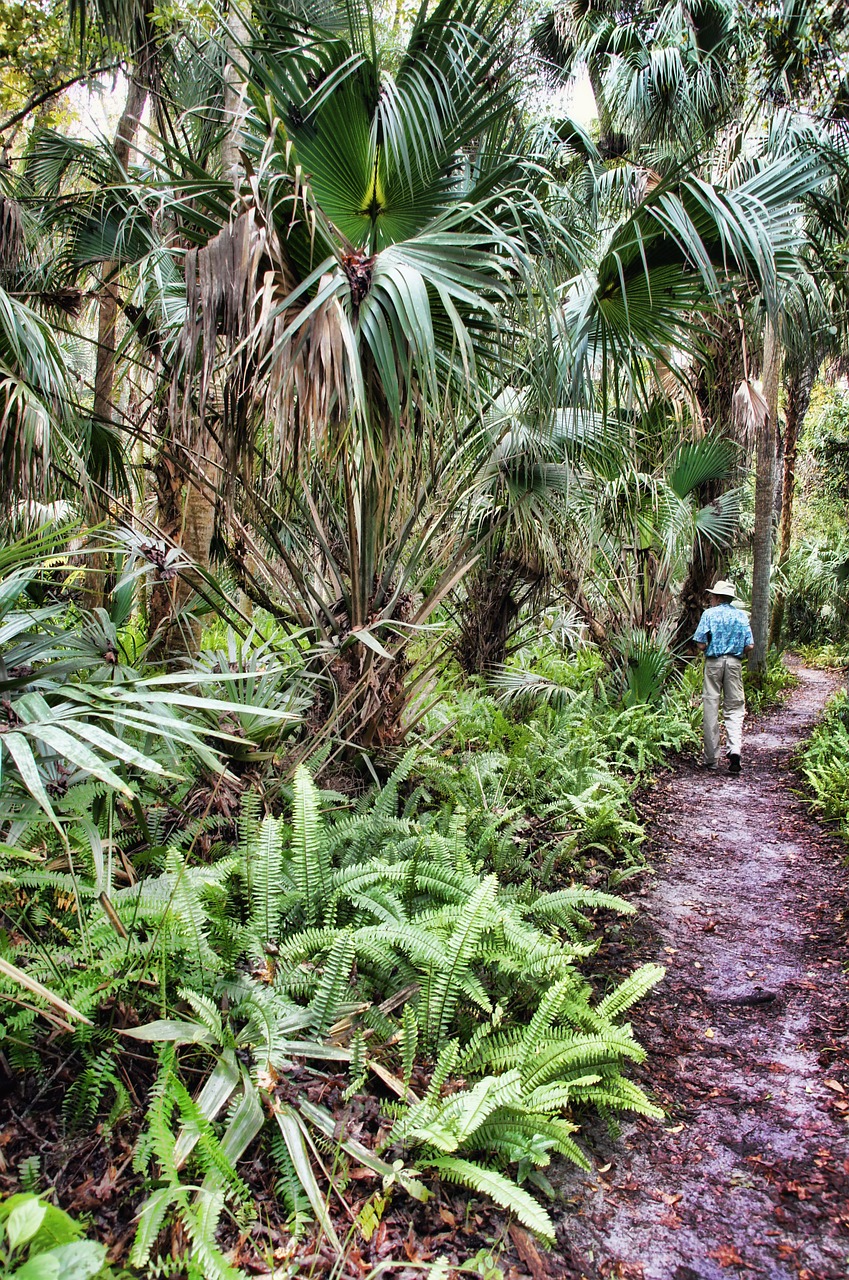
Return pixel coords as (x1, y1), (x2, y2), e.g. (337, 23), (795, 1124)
(3, 755), (662, 1276)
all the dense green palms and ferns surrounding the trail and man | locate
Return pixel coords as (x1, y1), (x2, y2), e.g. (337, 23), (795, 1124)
(0, 0), (849, 1280)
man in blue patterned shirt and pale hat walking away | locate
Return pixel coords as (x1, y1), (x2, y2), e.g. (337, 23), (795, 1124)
(693, 579), (754, 773)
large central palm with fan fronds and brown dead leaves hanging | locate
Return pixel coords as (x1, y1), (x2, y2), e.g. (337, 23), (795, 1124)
(131, 0), (570, 742)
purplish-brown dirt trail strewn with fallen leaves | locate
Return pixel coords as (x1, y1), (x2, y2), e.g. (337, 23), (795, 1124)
(558, 669), (849, 1280)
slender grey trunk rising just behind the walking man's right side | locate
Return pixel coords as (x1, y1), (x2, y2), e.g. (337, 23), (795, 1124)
(749, 320), (781, 681)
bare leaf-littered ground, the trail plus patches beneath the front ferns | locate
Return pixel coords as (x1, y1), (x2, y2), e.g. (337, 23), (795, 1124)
(0, 669), (849, 1280)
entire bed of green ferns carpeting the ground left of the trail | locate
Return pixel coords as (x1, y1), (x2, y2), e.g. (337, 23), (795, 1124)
(0, 636), (700, 1280)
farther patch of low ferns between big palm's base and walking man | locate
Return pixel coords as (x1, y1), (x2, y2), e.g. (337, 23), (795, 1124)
(417, 650), (700, 884)
